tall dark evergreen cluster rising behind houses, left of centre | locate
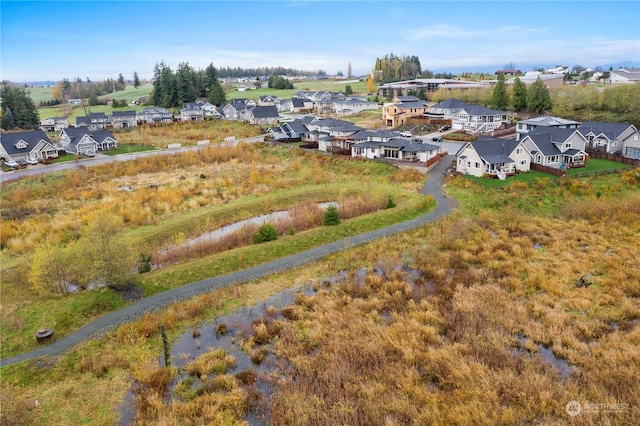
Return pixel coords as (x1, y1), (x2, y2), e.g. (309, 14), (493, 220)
(150, 61), (226, 108)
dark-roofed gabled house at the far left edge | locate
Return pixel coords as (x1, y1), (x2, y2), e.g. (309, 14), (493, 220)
(0, 130), (58, 161)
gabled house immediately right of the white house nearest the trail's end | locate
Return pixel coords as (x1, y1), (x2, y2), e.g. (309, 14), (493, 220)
(522, 127), (587, 169)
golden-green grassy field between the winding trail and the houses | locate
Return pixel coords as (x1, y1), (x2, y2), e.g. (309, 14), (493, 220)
(0, 141), (430, 357)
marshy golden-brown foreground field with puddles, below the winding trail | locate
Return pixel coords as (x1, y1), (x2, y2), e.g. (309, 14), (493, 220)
(0, 159), (640, 425)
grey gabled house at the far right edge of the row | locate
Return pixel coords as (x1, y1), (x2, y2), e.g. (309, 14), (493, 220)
(578, 121), (640, 158)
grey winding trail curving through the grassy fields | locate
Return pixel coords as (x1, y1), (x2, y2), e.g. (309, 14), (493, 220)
(0, 155), (456, 367)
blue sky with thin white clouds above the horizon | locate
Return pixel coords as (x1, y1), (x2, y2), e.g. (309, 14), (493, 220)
(0, 0), (640, 82)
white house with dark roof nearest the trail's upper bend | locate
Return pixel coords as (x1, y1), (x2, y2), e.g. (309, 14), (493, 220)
(456, 136), (531, 179)
